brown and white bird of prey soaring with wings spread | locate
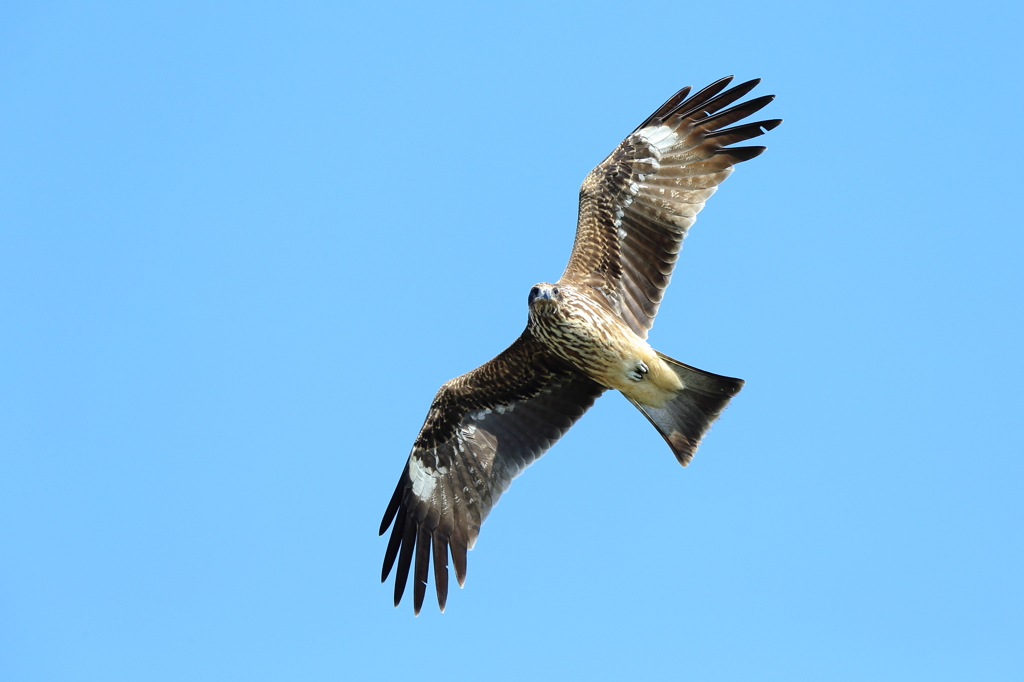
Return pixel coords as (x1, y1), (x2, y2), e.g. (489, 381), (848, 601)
(380, 77), (781, 613)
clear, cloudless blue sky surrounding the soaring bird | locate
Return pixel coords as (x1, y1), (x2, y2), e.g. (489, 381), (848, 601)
(0, 1), (1024, 682)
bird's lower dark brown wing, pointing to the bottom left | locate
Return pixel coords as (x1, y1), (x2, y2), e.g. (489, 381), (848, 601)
(380, 332), (605, 613)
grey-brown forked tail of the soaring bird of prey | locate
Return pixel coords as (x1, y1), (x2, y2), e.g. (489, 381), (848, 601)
(627, 351), (743, 467)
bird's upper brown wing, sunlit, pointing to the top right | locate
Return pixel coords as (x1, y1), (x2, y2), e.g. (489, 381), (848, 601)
(560, 77), (781, 339)
